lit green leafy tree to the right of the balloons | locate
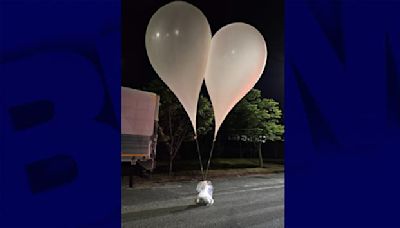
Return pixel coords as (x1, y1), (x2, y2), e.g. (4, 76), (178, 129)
(224, 89), (284, 167)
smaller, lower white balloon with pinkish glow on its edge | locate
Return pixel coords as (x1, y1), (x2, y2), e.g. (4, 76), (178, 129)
(205, 23), (267, 139)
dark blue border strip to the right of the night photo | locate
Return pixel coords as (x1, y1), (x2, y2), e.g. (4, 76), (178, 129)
(285, 0), (400, 227)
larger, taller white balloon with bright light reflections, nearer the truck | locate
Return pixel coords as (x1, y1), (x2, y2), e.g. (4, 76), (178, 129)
(146, 1), (211, 132)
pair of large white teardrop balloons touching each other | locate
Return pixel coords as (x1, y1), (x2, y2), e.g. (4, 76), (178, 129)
(146, 1), (267, 139)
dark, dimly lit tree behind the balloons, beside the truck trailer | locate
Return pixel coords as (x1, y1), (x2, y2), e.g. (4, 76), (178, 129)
(144, 79), (213, 175)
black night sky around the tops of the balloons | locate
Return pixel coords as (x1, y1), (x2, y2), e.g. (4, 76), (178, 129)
(122, 0), (284, 105)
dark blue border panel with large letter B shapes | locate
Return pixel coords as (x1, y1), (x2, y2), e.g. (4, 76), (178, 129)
(0, 0), (121, 227)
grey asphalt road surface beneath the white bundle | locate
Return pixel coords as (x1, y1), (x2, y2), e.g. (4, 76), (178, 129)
(122, 174), (284, 228)
